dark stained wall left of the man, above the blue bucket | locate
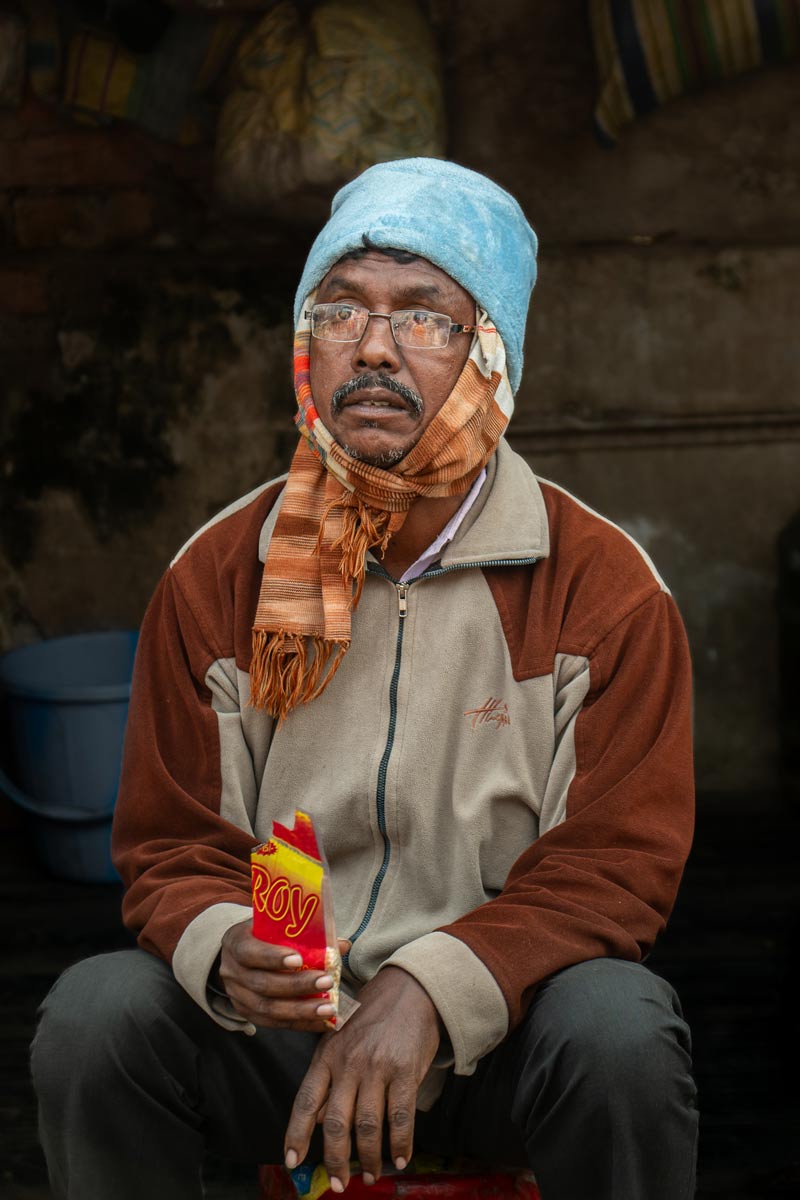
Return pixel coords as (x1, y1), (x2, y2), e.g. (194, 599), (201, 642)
(0, 91), (309, 649)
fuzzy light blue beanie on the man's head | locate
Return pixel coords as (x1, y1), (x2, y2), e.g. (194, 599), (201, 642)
(294, 158), (536, 392)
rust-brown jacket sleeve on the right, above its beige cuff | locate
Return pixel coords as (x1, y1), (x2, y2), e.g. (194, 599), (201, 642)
(443, 587), (693, 1027)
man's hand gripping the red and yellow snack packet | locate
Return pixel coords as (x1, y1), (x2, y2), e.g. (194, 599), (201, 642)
(219, 920), (345, 1033)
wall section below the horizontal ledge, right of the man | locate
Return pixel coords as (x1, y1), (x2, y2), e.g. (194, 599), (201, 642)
(529, 443), (800, 791)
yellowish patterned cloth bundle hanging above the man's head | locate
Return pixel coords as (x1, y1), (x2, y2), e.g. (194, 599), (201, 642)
(216, 0), (445, 210)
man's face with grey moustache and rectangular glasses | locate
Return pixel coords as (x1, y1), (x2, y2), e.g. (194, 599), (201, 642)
(311, 251), (475, 467)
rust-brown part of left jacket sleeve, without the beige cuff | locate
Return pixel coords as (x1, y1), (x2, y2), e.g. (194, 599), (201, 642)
(112, 571), (255, 961)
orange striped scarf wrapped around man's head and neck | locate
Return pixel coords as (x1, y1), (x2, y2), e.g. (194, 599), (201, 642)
(251, 312), (513, 721)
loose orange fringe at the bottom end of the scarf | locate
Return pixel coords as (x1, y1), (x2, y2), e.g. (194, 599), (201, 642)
(249, 629), (349, 725)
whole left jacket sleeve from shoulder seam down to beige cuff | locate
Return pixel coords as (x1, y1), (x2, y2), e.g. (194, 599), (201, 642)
(112, 484), (281, 964)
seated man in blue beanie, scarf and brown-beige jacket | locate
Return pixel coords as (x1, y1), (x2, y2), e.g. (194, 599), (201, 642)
(34, 160), (697, 1200)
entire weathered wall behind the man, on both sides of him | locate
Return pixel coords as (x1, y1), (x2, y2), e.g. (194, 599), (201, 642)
(0, 0), (800, 788)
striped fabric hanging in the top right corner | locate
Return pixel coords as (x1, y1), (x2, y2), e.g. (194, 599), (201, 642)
(589, 0), (800, 144)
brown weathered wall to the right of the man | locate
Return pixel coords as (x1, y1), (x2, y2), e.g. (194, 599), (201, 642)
(447, 0), (800, 790)
